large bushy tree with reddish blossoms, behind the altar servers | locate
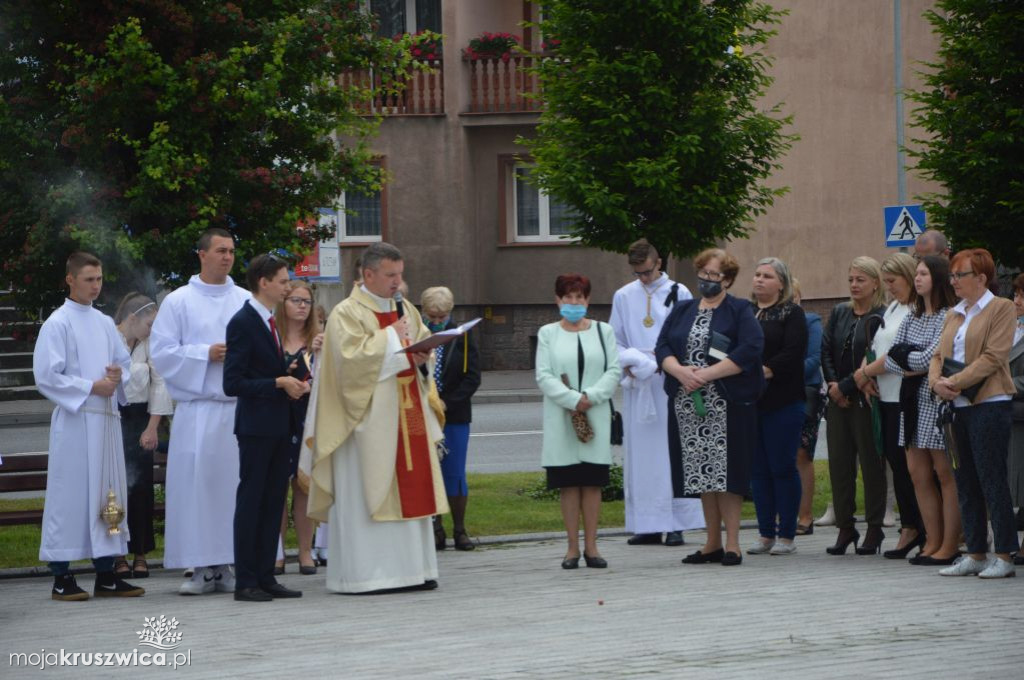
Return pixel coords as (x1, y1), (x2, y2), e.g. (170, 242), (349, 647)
(0, 0), (410, 309)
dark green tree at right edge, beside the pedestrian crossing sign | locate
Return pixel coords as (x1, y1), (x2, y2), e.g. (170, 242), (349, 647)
(907, 0), (1024, 267)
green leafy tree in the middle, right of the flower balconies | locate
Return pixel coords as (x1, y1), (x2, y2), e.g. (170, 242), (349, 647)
(521, 0), (795, 256)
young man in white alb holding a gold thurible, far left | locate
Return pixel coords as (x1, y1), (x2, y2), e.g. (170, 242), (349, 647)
(32, 253), (145, 601)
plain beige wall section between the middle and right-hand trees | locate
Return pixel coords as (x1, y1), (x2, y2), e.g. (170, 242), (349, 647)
(729, 0), (938, 299)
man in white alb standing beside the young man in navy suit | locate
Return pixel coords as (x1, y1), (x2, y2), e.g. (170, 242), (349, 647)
(150, 228), (252, 595)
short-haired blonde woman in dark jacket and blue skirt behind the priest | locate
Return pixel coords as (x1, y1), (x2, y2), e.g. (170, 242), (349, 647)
(420, 286), (480, 550)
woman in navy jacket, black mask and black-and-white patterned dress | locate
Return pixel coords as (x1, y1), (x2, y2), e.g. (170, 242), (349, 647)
(654, 248), (765, 565)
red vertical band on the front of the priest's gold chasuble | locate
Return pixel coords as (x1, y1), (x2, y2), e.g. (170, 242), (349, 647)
(374, 311), (437, 519)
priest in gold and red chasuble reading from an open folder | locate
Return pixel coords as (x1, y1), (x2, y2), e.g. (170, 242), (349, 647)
(308, 243), (447, 593)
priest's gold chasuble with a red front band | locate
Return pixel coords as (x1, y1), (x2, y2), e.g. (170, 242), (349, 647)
(308, 289), (449, 521)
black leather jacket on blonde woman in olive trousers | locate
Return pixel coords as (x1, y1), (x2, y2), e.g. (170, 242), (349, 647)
(821, 302), (886, 397)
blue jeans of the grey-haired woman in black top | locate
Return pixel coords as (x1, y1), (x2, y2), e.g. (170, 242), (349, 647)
(751, 399), (804, 539)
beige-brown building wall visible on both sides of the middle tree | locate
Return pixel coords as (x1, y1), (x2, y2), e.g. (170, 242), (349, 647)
(323, 0), (937, 368)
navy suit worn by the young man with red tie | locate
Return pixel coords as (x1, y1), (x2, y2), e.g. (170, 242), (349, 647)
(224, 301), (293, 590)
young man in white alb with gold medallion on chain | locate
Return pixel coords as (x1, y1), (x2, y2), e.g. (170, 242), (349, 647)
(611, 239), (705, 546)
